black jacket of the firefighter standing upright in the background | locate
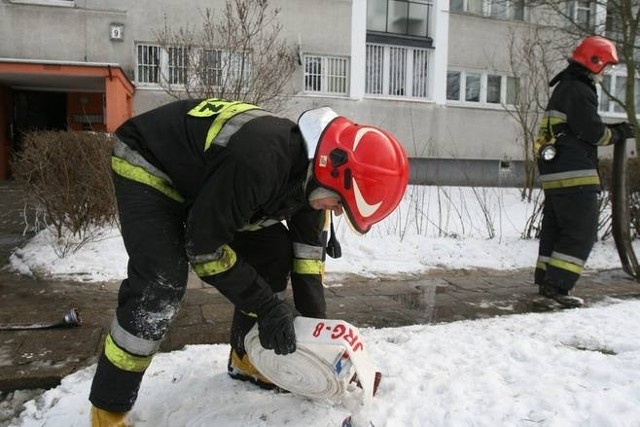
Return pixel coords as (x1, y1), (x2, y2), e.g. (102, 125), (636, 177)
(538, 64), (612, 194)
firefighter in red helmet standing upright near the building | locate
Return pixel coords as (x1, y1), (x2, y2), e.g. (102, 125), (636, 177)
(534, 36), (634, 307)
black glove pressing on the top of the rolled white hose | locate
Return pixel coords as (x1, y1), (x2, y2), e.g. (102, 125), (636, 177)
(256, 295), (296, 355)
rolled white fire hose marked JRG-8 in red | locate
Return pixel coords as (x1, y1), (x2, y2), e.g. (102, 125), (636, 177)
(244, 316), (376, 403)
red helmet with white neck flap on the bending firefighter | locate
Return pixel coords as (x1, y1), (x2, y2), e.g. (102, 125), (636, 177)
(298, 107), (409, 234)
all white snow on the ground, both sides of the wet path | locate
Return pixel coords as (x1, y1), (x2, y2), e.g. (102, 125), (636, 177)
(5, 187), (640, 427)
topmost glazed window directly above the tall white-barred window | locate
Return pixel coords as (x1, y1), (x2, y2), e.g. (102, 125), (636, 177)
(367, 0), (432, 38)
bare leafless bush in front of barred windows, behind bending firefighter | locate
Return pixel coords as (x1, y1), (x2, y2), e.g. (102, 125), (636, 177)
(156, 0), (297, 110)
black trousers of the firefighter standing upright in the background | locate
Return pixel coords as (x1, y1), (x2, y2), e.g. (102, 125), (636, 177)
(534, 191), (598, 292)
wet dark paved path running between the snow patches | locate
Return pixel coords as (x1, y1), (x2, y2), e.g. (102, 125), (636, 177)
(0, 182), (640, 408)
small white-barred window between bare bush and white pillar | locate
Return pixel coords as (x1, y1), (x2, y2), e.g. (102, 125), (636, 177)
(304, 55), (349, 95)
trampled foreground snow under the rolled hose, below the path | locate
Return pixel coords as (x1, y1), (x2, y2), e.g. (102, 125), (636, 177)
(11, 301), (640, 427)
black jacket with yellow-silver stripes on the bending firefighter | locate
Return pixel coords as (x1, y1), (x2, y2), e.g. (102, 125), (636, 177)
(112, 99), (325, 311)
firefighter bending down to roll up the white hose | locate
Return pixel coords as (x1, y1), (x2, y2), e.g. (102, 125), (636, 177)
(89, 99), (408, 426)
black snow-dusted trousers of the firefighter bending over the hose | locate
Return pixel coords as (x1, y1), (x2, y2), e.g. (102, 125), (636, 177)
(89, 175), (316, 412)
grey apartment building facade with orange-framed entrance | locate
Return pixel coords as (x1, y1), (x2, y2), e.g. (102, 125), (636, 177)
(0, 0), (628, 185)
